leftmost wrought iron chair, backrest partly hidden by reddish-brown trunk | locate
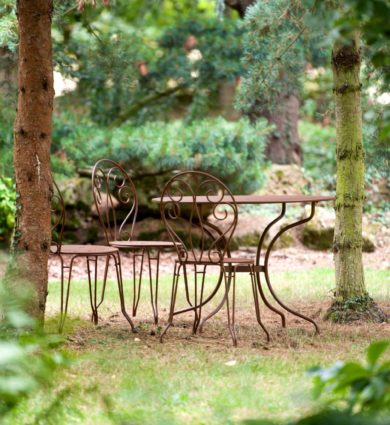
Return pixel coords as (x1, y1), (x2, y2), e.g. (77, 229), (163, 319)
(50, 181), (134, 332)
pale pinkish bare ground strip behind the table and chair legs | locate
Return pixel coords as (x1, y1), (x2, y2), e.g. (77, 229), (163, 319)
(49, 245), (390, 280)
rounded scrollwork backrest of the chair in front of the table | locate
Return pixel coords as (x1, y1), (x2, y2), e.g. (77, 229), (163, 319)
(160, 171), (238, 264)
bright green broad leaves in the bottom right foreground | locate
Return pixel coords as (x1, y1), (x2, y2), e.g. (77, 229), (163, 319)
(308, 341), (390, 413)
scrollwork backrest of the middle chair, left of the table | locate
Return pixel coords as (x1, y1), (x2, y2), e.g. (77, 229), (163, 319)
(92, 159), (138, 244)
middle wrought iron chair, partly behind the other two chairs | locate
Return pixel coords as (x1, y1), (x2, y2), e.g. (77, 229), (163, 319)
(92, 159), (174, 324)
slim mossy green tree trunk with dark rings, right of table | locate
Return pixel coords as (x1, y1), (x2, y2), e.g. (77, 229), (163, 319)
(329, 35), (384, 321)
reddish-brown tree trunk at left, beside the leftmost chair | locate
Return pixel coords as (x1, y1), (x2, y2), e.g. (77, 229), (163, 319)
(8, 0), (54, 319)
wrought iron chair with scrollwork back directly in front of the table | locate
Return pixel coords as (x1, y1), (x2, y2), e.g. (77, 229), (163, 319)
(160, 171), (269, 346)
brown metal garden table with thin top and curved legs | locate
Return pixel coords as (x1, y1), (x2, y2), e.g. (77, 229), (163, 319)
(152, 195), (335, 333)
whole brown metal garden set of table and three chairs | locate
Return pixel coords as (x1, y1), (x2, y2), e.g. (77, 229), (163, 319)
(51, 159), (334, 346)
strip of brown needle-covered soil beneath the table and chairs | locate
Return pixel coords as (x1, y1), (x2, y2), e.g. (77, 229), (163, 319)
(69, 302), (390, 354)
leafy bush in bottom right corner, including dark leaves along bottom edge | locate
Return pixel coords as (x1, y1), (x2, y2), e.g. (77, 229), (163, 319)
(243, 341), (390, 425)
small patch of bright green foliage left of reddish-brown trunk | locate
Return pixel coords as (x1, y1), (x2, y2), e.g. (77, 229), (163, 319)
(0, 176), (16, 241)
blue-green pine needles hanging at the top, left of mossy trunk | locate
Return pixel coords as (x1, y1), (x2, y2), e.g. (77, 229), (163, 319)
(239, 0), (329, 111)
